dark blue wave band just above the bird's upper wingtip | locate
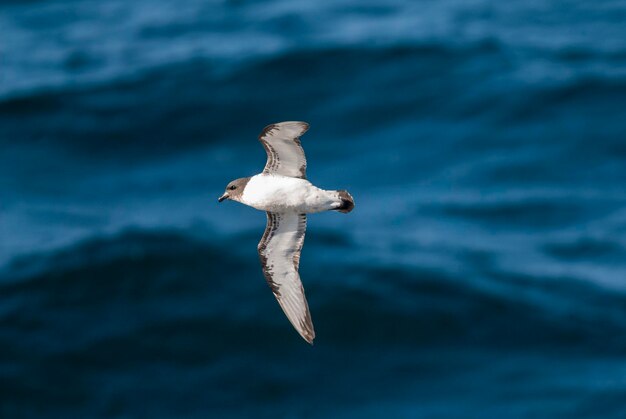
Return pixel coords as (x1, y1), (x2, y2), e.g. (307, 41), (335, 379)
(0, 42), (626, 159)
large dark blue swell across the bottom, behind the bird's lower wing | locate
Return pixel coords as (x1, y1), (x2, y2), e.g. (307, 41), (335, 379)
(0, 230), (626, 418)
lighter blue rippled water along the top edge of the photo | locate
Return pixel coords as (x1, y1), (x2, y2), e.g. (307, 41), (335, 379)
(0, 0), (626, 102)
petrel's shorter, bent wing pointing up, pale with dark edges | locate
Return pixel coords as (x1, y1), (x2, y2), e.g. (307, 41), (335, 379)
(259, 121), (309, 179)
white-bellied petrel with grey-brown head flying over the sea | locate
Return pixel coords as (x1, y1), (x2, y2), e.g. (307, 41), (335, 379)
(218, 121), (354, 344)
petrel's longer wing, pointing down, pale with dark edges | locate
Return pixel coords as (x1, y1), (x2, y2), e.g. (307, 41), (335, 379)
(258, 212), (315, 344)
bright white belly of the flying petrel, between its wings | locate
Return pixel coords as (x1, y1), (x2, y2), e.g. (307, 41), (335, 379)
(241, 174), (337, 213)
